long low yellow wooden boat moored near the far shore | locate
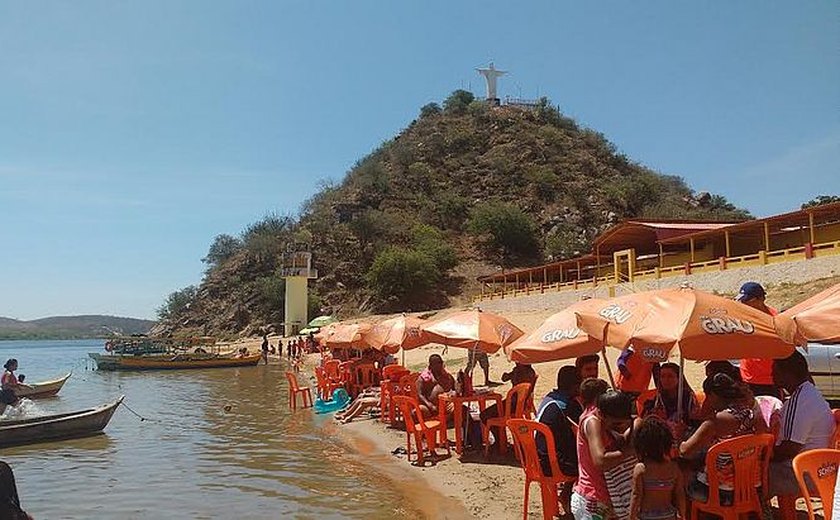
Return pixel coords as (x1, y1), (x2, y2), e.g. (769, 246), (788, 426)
(88, 352), (262, 370)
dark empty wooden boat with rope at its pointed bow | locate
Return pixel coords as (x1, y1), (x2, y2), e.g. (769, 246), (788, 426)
(0, 396), (125, 447)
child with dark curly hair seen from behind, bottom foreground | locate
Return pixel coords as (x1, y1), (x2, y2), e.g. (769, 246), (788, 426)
(630, 416), (686, 520)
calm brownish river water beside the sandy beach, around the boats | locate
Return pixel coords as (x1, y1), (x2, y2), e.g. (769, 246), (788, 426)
(0, 341), (426, 520)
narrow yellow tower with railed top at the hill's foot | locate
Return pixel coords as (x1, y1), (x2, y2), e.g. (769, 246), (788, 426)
(282, 246), (318, 337)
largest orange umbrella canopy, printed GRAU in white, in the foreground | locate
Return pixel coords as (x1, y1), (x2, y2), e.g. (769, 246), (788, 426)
(576, 288), (796, 361)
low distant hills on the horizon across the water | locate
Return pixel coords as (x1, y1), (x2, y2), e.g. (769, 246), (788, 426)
(0, 315), (155, 339)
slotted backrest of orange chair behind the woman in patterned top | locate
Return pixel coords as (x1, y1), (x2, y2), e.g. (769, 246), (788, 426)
(706, 433), (773, 508)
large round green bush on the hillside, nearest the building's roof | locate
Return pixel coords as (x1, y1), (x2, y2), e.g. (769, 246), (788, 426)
(467, 202), (539, 265)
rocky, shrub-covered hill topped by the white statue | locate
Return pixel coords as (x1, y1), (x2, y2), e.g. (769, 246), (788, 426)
(159, 91), (749, 334)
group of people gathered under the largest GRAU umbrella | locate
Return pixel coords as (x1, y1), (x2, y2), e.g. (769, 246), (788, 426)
(537, 351), (835, 520)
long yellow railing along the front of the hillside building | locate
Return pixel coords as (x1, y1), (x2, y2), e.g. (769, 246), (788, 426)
(474, 241), (840, 301)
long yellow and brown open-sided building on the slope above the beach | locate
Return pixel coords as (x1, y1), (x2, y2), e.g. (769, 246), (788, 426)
(476, 202), (840, 300)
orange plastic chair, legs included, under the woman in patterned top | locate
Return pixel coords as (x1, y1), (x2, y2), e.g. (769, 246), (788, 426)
(691, 433), (773, 520)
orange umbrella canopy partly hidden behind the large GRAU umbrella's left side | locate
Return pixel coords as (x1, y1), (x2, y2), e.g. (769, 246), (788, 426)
(505, 299), (604, 365)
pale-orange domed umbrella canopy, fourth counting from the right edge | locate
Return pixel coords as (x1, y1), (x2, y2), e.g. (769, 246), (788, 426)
(423, 310), (523, 354)
